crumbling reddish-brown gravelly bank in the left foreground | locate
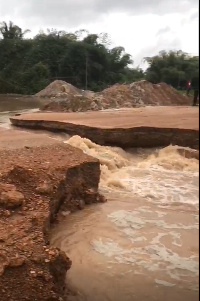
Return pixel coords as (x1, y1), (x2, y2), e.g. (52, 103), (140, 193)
(0, 144), (104, 301)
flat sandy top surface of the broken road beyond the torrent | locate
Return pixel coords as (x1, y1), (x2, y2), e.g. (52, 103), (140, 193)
(12, 107), (199, 130)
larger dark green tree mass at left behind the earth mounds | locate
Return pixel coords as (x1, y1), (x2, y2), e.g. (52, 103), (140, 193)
(0, 22), (144, 94)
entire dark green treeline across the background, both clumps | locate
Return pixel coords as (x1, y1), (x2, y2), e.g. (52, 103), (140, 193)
(0, 22), (199, 94)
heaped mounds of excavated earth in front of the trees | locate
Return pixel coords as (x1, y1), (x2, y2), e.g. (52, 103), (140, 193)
(36, 80), (190, 112)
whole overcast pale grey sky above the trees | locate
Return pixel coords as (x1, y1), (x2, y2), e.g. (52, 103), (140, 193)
(0, 0), (199, 65)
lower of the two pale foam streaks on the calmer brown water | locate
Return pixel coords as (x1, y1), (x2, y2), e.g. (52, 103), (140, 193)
(92, 239), (199, 280)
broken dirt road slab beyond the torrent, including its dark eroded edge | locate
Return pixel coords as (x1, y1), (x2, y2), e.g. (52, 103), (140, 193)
(11, 107), (199, 149)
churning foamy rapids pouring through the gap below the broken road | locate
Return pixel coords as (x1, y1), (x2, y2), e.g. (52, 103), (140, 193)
(65, 136), (199, 205)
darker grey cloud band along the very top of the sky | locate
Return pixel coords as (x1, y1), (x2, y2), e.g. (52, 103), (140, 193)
(0, 0), (198, 27)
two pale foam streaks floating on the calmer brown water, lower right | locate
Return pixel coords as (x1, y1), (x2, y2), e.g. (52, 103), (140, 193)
(92, 207), (199, 280)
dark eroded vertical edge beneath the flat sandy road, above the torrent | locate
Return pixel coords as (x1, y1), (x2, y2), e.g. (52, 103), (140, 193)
(12, 119), (199, 149)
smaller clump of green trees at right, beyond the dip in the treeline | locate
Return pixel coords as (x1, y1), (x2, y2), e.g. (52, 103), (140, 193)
(145, 51), (199, 89)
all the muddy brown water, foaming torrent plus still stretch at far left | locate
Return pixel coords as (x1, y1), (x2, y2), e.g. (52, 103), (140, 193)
(0, 96), (199, 301)
